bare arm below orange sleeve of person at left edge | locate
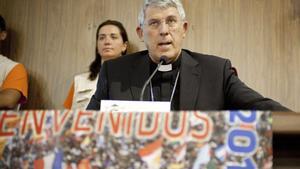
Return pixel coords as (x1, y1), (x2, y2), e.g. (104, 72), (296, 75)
(0, 89), (22, 109)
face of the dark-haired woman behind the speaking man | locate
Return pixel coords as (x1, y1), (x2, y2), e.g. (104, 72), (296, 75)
(97, 25), (127, 61)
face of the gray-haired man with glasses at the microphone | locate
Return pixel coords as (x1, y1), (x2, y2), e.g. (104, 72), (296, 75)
(137, 6), (188, 63)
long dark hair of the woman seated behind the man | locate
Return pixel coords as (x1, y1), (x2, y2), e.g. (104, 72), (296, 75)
(89, 20), (128, 80)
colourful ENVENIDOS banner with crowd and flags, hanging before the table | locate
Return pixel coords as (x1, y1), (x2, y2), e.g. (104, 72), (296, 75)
(0, 110), (273, 169)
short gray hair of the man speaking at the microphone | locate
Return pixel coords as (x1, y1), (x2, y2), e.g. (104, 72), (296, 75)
(138, 0), (185, 26)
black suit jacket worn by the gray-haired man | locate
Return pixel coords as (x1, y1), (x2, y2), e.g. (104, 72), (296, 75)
(87, 50), (290, 111)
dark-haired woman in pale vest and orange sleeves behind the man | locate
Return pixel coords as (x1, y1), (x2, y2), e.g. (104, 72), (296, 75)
(64, 20), (129, 109)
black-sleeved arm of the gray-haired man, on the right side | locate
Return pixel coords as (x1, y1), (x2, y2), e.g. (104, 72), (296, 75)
(224, 60), (291, 111)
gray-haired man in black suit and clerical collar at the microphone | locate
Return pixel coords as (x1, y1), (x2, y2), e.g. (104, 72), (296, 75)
(87, 0), (288, 111)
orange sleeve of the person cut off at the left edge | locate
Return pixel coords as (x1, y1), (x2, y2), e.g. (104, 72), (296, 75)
(2, 64), (28, 103)
